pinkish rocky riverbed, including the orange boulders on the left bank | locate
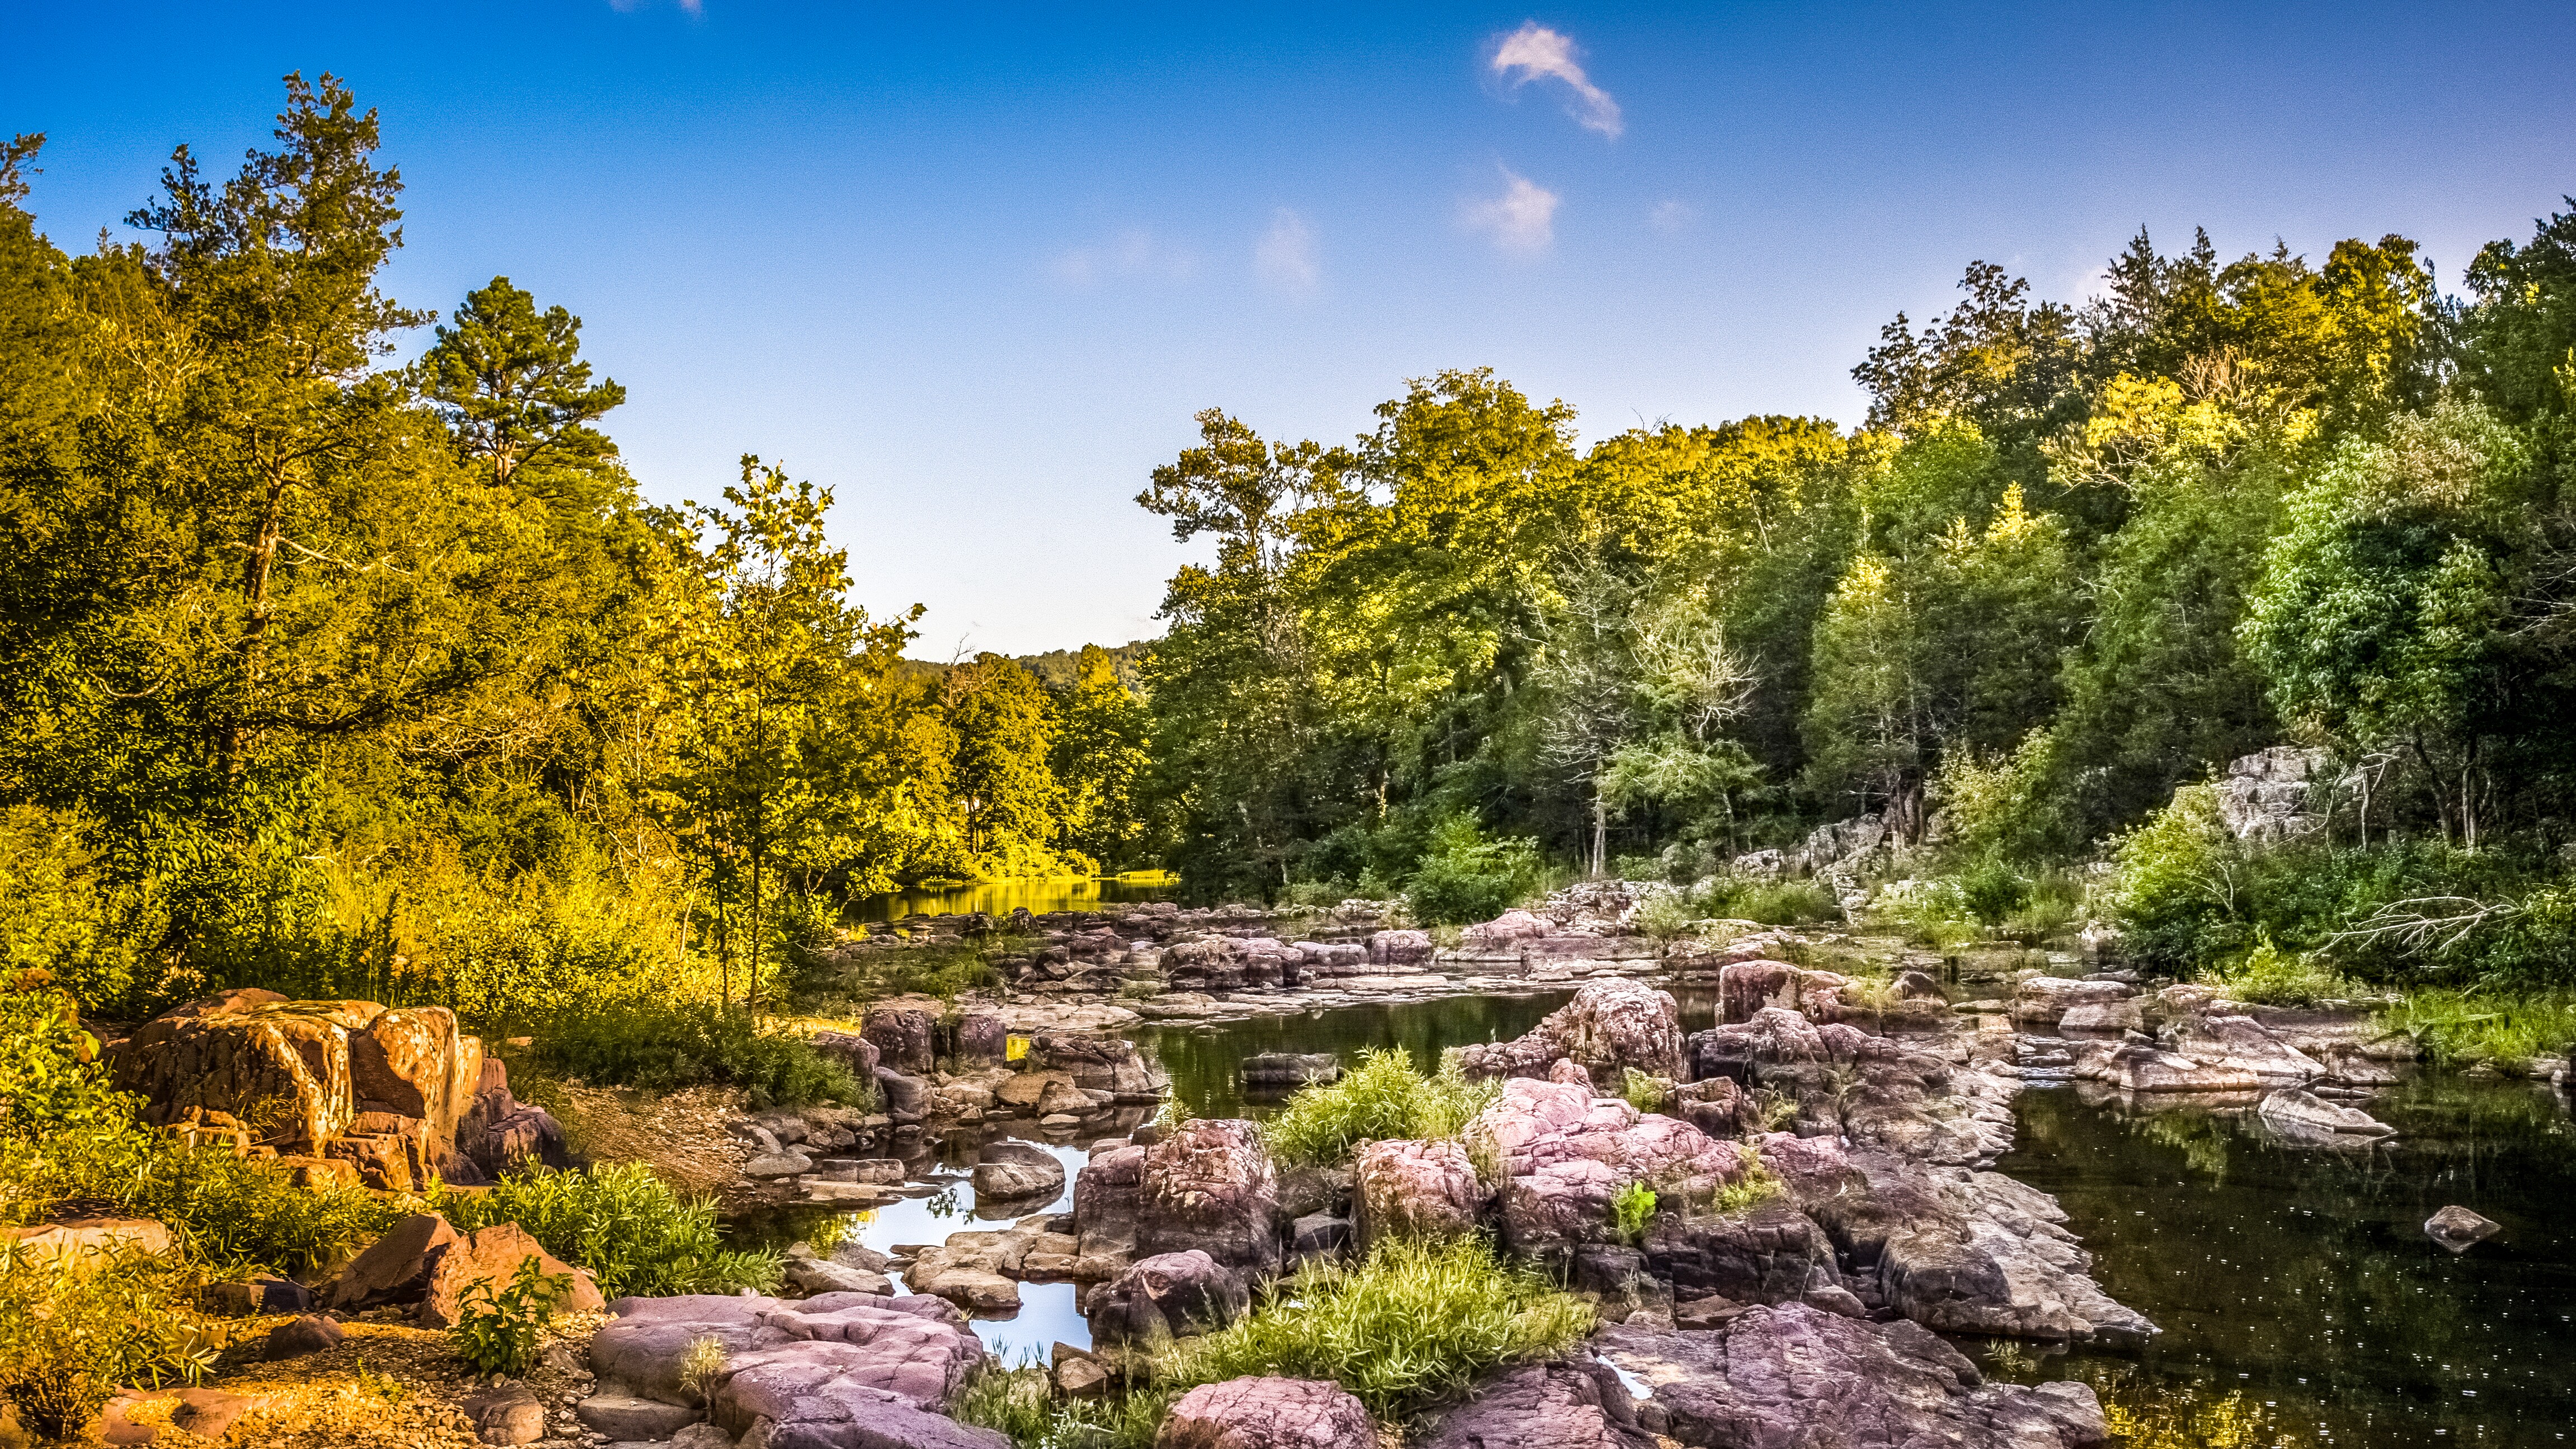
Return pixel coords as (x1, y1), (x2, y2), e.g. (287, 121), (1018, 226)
(65, 886), (2576, 1449)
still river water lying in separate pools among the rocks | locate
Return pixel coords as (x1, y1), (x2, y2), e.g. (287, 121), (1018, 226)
(739, 991), (2576, 1449)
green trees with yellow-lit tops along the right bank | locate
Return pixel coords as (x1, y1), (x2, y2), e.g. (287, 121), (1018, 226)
(1139, 193), (2576, 983)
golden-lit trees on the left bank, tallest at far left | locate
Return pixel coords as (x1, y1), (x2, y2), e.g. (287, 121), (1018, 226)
(0, 77), (1146, 1017)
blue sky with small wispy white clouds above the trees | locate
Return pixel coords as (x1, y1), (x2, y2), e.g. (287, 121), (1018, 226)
(15, 0), (2576, 656)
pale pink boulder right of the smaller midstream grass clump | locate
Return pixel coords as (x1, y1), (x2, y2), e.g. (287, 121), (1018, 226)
(1466, 1079), (1749, 1251)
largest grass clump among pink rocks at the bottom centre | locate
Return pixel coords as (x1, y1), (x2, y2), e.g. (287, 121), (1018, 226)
(1157, 1235), (1592, 1423)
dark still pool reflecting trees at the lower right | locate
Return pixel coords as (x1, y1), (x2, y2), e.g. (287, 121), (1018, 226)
(1999, 1079), (2576, 1444)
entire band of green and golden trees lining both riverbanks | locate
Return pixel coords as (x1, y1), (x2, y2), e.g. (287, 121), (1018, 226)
(0, 77), (2576, 1019)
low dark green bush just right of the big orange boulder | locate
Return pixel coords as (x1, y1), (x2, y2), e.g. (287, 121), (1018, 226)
(533, 1001), (873, 1107)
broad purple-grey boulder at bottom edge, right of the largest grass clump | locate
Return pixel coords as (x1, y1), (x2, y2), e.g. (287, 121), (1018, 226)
(1595, 1302), (2107, 1449)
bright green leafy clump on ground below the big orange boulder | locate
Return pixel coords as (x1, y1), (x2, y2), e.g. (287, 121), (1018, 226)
(438, 1163), (783, 1297)
